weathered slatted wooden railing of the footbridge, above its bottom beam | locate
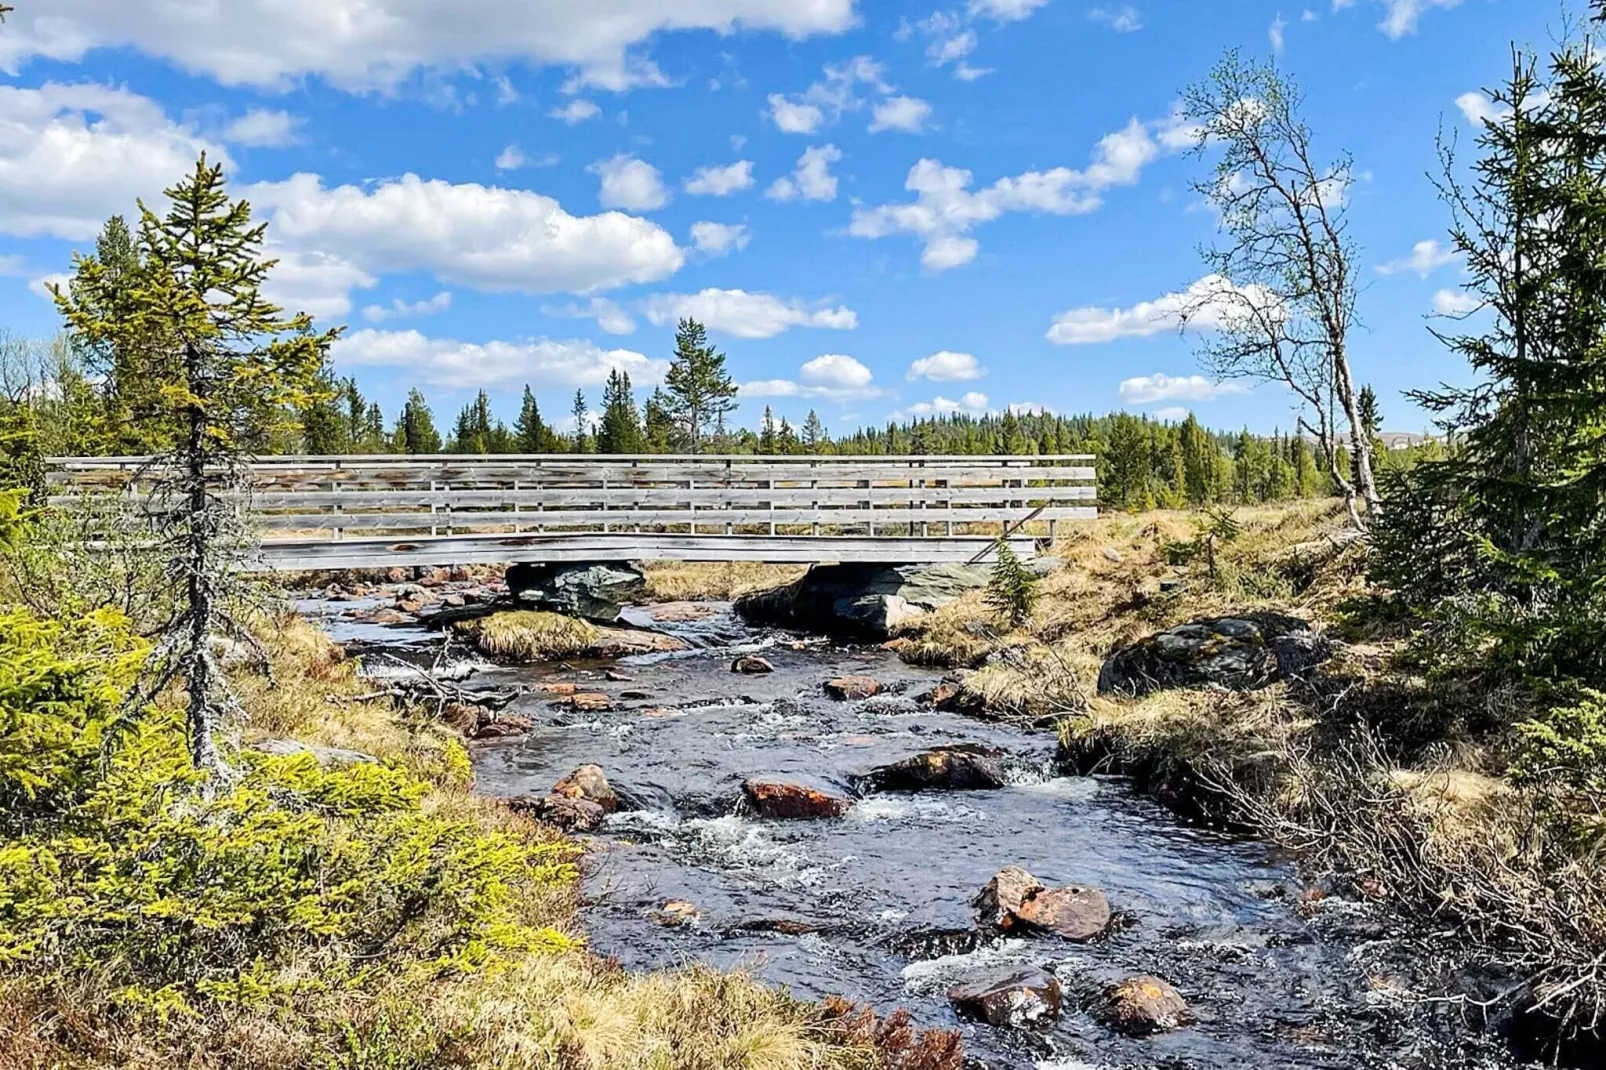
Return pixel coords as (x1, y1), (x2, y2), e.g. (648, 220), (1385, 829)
(50, 455), (1097, 545)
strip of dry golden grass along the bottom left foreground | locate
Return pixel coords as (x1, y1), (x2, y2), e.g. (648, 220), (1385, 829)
(0, 953), (905, 1070)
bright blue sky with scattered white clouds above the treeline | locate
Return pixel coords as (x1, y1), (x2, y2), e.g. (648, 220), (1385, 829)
(0, 0), (1567, 432)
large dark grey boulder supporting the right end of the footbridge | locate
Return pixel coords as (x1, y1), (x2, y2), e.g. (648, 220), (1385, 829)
(736, 564), (988, 638)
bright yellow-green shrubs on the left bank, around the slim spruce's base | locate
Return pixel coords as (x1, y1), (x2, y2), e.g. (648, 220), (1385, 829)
(0, 600), (573, 1012)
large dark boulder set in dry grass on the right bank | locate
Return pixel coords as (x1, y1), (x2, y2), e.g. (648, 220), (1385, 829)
(1099, 612), (1333, 696)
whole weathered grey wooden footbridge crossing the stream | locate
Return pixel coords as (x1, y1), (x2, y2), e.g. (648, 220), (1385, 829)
(50, 455), (1097, 570)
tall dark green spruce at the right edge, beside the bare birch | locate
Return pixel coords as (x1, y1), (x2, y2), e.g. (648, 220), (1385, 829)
(1375, 35), (1606, 680)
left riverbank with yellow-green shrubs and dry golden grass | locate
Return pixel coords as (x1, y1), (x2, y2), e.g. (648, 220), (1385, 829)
(0, 617), (941, 1070)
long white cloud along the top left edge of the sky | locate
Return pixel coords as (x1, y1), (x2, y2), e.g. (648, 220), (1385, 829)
(0, 0), (856, 90)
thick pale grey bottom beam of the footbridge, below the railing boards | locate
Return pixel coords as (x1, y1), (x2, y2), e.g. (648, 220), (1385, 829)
(247, 533), (1036, 572)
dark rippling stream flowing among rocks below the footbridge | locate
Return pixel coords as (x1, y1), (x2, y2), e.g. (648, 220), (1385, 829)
(302, 601), (1518, 1070)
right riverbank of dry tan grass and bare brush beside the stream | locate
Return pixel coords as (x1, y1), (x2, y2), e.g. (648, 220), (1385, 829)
(895, 503), (1606, 1062)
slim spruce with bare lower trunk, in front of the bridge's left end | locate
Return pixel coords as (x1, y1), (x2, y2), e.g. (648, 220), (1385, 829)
(55, 154), (339, 779)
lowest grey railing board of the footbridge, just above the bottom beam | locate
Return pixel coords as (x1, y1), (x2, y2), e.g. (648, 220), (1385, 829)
(251, 506), (1099, 532)
